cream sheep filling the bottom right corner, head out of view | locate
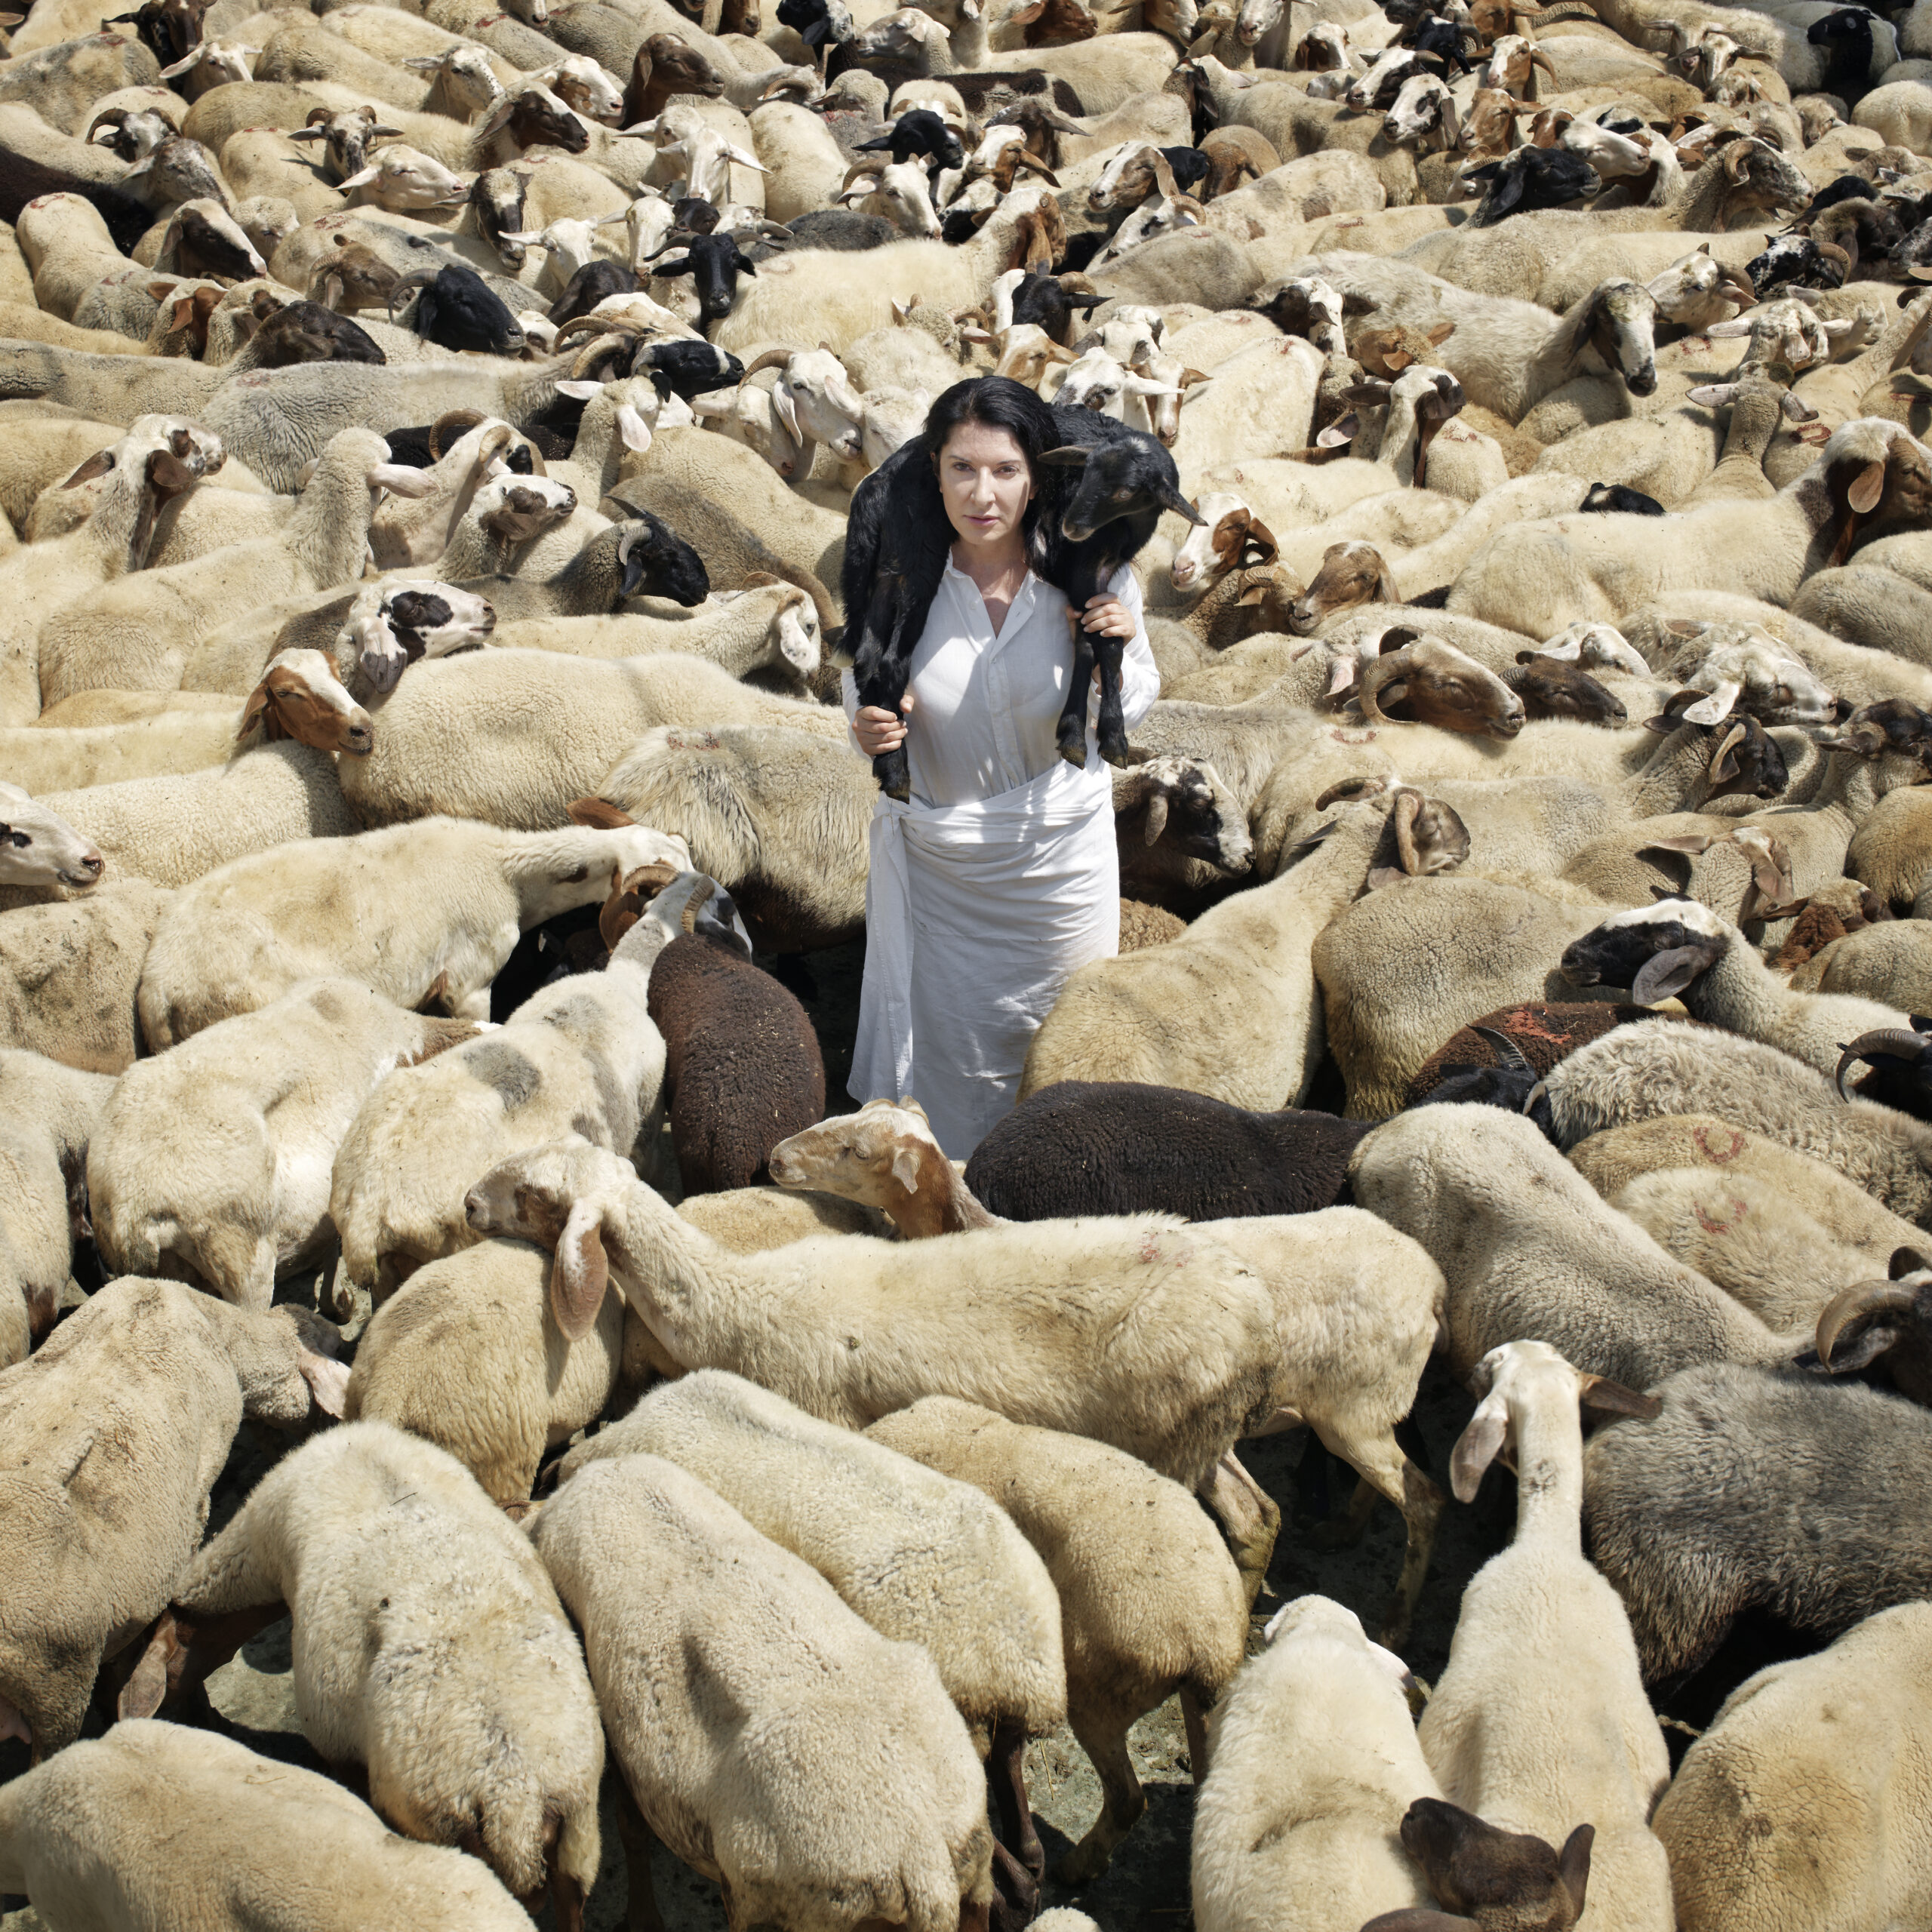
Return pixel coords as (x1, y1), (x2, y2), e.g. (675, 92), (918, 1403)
(1652, 1604), (1932, 1932)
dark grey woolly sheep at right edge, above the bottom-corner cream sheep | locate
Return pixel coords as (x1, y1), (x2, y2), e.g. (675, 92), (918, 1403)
(1583, 1362), (1932, 1683)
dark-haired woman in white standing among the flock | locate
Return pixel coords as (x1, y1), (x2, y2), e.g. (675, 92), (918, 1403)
(844, 377), (1159, 1161)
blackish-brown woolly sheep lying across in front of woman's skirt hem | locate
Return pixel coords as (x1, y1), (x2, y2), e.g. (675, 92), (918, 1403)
(966, 1080), (1374, 1221)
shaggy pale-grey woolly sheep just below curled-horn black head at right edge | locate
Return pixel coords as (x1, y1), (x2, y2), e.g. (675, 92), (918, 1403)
(1546, 1020), (1932, 1229)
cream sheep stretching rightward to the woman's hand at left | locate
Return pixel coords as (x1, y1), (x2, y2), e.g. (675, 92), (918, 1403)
(330, 649), (844, 832)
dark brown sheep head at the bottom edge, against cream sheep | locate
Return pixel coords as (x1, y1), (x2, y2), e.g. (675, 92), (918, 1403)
(1362, 1798), (1596, 1932)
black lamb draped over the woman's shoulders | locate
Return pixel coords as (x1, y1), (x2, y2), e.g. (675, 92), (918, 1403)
(841, 408), (1201, 798)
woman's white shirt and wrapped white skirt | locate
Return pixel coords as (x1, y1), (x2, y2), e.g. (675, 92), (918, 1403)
(844, 562), (1161, 1159)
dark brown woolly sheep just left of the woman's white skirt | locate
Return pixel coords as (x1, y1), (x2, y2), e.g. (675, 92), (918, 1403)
(651, 933), (825, 1194)
